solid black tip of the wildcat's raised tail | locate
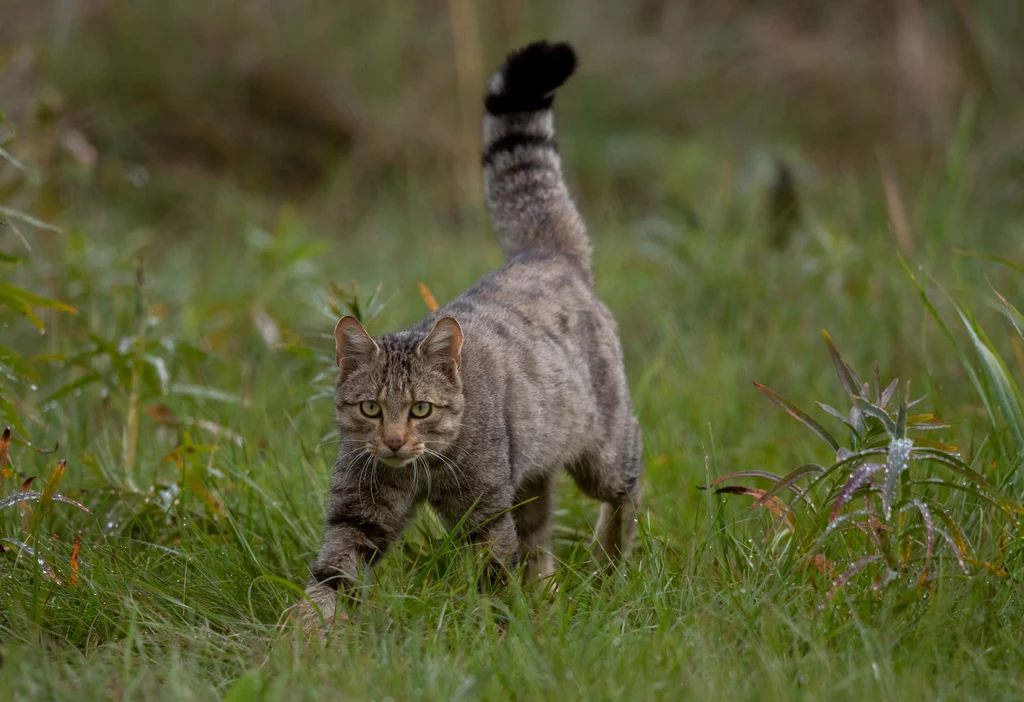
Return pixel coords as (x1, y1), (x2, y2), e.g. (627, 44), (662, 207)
(485, 41), (578, 115)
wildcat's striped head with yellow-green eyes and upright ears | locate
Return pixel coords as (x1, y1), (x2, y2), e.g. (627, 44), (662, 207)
(334, 317), (464, 468)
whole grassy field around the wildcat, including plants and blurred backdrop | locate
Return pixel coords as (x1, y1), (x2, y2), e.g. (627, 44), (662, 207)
(0, 0), (1024, 702)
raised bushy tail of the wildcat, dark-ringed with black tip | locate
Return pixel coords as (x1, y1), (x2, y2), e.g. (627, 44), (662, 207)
(483, 41), (591, 278)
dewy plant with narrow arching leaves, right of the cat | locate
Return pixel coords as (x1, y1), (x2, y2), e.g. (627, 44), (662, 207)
(707, 333), (1024, 600)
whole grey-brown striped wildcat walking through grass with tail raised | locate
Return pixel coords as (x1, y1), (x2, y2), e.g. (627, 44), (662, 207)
(300, 41), (643, 624)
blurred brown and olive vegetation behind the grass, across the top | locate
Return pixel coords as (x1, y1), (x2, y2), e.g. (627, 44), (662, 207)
(0, 0), (1024, 233)
